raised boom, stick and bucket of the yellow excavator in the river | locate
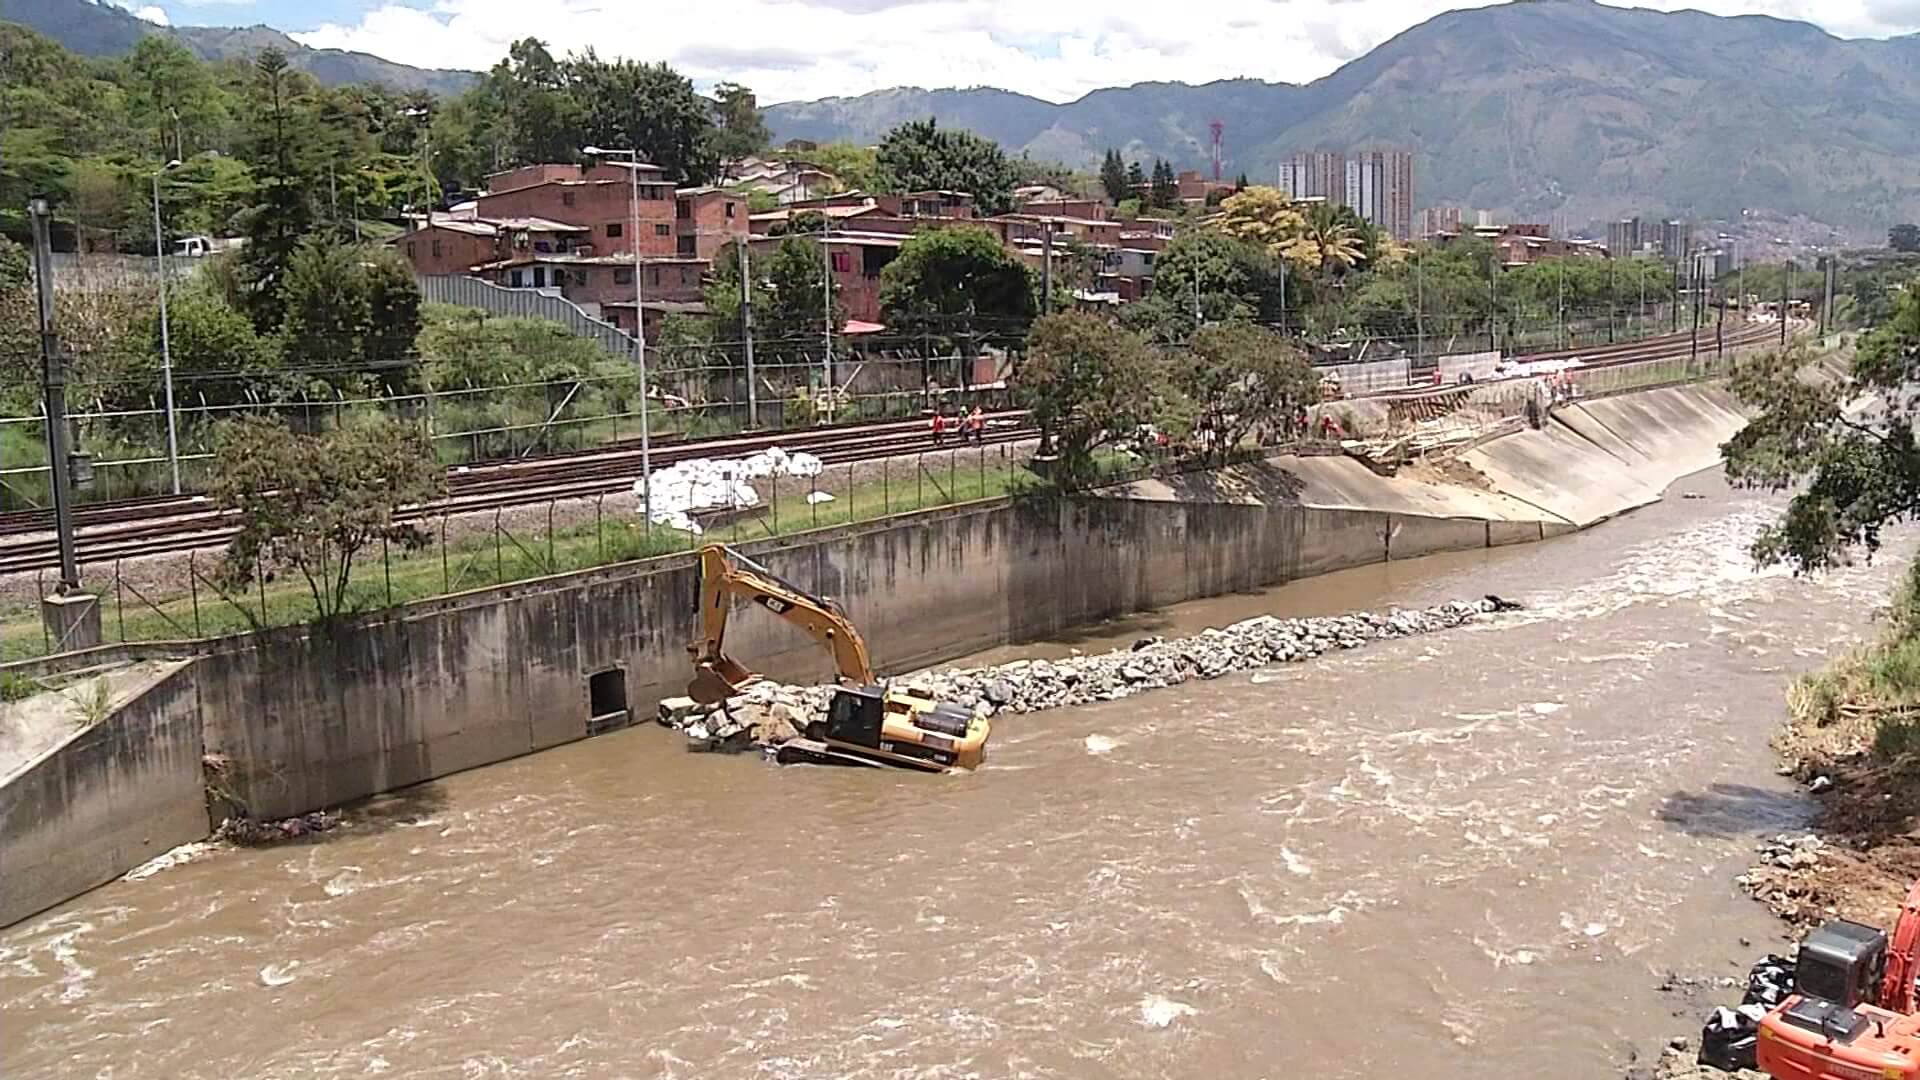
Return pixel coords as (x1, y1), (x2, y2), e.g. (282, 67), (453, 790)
(687, 544), (876, 705)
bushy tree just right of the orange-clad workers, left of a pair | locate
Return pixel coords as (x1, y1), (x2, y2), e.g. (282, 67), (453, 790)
(1014, 311), (1160, 486)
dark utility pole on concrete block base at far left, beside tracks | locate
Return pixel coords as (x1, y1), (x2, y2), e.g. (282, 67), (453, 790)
(27, 198), (100, 651)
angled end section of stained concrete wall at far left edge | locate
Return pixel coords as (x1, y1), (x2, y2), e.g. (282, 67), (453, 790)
(0, 665), (207, 924)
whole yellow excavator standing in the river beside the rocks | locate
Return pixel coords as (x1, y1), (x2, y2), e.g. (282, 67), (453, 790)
(687, 544), (991, 773)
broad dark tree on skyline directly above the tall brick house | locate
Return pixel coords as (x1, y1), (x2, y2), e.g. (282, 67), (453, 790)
(564, 48), (720, 184)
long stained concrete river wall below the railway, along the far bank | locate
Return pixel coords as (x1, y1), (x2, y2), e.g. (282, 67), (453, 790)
(0, 380), (1743, 926)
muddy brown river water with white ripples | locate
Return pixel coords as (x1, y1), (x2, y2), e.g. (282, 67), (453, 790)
(0, 475), (1907, 1080)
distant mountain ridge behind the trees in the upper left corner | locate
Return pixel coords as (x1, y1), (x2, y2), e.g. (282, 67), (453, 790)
(0, 0), (478, 94)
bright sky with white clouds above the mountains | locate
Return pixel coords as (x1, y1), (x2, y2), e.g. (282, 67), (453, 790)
(123, 0), (1920, 104)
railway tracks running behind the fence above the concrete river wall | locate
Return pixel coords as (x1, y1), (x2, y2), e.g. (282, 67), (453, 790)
(0, 327), (1778, 577)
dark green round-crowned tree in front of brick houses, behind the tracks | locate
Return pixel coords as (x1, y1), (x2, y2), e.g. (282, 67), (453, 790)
(879, 229), (1035, 338)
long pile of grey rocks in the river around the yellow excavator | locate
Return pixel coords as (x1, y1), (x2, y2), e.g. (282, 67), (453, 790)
(660, 598), (1503, 751)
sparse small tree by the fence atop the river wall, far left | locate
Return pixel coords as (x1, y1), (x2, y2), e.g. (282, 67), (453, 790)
(207, 417), (445, 621)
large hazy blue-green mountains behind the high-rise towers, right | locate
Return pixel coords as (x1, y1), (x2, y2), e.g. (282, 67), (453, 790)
(766, 0), (1920, 236)
